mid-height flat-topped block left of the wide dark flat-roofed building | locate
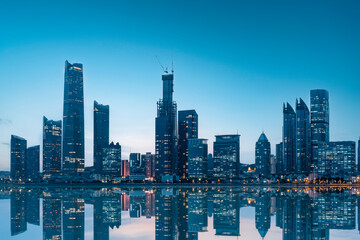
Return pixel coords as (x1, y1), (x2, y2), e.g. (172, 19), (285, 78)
(187, 138), (208, 181)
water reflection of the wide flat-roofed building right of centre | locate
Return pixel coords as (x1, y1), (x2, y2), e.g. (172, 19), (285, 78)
(213, 191), (240, 236)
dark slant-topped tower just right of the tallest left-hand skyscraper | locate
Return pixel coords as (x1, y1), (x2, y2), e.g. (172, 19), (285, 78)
(94, 101), (109, 174)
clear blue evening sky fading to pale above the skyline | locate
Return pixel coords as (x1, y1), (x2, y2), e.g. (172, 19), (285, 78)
(0, 0), (360, 170)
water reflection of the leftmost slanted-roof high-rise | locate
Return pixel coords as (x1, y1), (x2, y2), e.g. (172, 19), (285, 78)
(10, 188), (27, 236)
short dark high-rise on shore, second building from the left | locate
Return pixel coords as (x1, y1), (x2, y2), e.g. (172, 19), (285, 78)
(25, 145), (40, 182)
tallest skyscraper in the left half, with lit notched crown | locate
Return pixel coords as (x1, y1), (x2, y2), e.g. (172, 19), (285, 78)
(62, 61), (85, 174)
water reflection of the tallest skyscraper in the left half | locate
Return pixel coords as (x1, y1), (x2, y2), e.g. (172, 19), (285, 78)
(62, 196), (85, 240)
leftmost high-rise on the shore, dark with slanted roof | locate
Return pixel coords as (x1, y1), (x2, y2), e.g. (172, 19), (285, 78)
(10, 135), (27, 182)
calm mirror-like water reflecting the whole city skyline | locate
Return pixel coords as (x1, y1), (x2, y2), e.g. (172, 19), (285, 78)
(0, 187), (360, 240)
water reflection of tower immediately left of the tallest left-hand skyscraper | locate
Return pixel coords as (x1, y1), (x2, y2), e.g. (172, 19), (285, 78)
(43, 194), (62, 240)
